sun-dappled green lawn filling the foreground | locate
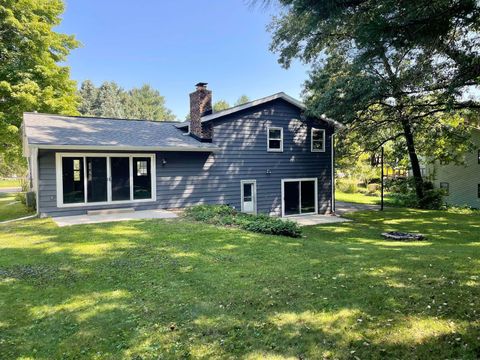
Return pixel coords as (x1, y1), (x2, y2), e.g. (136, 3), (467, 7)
(0, 205), (480, 359)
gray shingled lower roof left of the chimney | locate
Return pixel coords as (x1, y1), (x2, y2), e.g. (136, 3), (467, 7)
(23, 113), (218, 151)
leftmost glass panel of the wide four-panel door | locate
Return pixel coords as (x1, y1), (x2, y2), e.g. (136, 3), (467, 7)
(62, 157), (85, 204)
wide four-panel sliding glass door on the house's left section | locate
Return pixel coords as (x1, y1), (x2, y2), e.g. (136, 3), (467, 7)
(57, 153), (155, 207)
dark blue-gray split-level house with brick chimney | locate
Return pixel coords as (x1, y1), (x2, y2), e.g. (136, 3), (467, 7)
(23, 83), (336, 216)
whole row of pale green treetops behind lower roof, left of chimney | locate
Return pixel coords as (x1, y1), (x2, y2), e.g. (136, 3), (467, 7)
(78, 80), (176, 121)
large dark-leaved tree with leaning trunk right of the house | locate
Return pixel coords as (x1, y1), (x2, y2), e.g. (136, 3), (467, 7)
(271, 0), (480, 199)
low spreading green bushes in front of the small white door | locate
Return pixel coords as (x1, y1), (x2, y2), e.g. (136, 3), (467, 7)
(185, 205), (301, 237)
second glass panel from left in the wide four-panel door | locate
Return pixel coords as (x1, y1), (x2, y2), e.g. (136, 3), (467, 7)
(87, 157), (107, 202)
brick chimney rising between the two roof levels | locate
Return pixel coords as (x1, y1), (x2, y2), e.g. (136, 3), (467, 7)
(190, 82), (213, 141)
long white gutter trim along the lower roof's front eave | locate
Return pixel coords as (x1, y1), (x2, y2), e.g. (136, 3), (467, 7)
(31, 144), (220, 152)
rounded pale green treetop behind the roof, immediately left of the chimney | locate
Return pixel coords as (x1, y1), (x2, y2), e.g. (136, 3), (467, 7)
(125, 85), (175, 121)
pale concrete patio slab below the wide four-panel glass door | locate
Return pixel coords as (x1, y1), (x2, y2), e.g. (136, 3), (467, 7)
(52, 209), (178, 227)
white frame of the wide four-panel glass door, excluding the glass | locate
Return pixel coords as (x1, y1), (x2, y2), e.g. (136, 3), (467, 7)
(55, 153), (157, 208)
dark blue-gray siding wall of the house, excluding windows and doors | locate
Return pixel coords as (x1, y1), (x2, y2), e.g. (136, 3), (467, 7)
(39, 100), (333, 215)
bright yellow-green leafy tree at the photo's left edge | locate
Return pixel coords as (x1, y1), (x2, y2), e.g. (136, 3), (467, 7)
(0, 0), (78, 172)
